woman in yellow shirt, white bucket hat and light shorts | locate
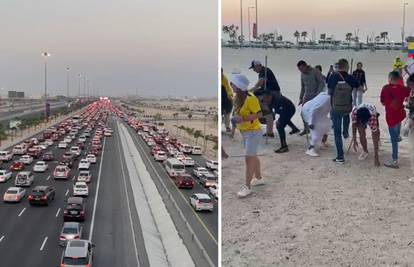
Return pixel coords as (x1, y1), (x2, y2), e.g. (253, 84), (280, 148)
(230, 74), (263, 197)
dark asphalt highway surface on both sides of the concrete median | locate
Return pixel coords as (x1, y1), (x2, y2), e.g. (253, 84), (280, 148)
(0, 105), (218, 266)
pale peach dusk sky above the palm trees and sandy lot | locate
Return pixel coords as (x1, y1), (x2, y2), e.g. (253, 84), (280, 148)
(221, 0), (414, 42)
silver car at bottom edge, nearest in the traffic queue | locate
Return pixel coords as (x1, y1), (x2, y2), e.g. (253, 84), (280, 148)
(60, 239), (93, 267)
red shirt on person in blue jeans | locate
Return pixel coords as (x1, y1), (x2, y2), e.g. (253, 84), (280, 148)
(381, 84), (410, 128)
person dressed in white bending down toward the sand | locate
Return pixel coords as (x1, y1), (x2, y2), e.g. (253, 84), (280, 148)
(302, 92), (332, 157)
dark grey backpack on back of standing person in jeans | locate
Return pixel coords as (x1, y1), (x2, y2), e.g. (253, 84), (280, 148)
(332, 72), (352, 115)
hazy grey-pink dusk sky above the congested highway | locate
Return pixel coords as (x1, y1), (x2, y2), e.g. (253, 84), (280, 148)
(0, 0), (218, 96)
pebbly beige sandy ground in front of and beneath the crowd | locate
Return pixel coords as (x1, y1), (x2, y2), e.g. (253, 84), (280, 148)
(222, 123), (414, 266)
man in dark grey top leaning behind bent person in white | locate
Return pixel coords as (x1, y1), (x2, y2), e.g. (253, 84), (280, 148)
(297, 60), (325, 136)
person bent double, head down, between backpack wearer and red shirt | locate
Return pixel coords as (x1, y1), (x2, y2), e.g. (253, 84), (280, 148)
(351, 103), (380, 167)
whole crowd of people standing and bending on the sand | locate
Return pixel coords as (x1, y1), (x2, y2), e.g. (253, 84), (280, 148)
(221, 58), (414, 197)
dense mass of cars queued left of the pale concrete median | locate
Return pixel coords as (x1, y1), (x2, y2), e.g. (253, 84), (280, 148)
(0, 101), (113, 266)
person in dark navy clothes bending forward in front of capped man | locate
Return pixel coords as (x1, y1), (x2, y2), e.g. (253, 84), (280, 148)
(263, 90), (299, 153)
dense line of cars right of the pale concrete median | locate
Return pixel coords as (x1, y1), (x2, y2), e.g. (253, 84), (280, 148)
(115, 110), (219, 212)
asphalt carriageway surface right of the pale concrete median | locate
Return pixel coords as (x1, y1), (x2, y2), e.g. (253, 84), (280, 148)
(125, 120), (218, 265)
